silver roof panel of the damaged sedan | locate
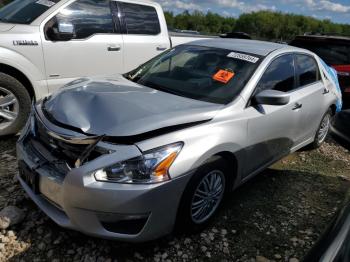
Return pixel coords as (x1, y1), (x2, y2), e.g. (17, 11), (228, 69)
(190, 38), (288, 56)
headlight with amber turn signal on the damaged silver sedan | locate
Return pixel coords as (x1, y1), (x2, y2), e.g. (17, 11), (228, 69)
(94, 143), (183, 184)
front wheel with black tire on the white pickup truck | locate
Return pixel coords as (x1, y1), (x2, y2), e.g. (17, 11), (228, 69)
(0, 73), (31, 136)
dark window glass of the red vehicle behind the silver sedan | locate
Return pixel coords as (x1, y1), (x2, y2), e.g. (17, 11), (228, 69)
(291, 40), (350, 65)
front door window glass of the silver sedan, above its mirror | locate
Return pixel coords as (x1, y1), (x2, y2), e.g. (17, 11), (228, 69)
(256, 54), (296, 94)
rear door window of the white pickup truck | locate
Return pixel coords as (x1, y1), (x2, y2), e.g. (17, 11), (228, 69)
(120, 3), (160, 35)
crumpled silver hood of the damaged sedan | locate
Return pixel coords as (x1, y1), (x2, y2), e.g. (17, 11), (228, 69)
(44, 76), (223, 137)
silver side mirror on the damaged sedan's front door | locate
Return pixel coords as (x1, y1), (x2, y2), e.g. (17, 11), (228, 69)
(254, 90), (290, 106)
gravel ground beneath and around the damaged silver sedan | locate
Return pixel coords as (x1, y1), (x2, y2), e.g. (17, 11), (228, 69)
(0, 138), (350, 262)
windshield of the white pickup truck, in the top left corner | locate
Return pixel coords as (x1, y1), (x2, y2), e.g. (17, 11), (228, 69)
(0, 0), (60, 24)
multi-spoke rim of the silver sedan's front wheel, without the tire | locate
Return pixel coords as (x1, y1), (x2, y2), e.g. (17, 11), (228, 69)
(191, 170), (225, 224)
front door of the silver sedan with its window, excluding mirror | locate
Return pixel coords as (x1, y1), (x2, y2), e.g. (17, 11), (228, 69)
(245, 54), (305, 175)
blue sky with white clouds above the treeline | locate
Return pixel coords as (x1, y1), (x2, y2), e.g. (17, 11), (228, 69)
(156, 0), (350, 24)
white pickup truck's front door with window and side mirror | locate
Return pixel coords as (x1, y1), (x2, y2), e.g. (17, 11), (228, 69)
(41, 0), (124, 92)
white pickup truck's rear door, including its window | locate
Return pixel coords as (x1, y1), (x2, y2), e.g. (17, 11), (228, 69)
(116, 2), (170, 72)
